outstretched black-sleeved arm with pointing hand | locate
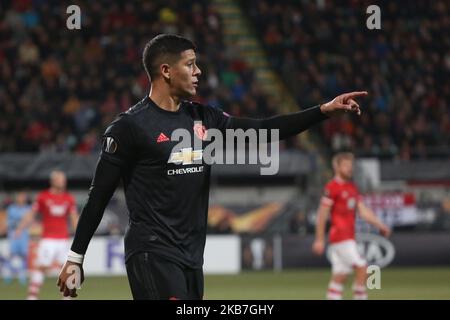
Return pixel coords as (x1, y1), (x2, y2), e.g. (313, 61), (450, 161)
(229, 91), (367, 139)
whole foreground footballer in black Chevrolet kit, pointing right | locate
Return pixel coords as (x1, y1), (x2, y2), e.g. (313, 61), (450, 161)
(58, 35), (363, 299)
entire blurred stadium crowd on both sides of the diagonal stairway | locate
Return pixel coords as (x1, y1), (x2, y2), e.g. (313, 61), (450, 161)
(0, 0), (450, 160)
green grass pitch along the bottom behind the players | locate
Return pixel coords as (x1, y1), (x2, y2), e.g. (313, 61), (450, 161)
(0, 267), (450, 300)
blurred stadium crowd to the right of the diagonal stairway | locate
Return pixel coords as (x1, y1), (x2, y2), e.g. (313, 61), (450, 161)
(241, 0), (450, 160)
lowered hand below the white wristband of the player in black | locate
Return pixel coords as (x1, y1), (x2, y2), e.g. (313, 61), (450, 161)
(56, 261), (84, 298)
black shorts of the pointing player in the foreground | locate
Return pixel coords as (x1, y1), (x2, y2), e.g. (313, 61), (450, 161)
(126, 252), (204, 300)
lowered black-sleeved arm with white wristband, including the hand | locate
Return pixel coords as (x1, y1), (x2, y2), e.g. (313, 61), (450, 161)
(57, 158), (121, 297)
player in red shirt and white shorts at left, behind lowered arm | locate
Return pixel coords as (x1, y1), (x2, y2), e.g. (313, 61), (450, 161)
(16, 170), (78, 300)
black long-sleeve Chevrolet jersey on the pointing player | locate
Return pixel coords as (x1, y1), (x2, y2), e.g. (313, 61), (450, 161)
(71, 97), (326, 268)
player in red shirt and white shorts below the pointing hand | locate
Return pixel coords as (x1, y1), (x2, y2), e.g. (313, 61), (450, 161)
(312, 152), (391, 300)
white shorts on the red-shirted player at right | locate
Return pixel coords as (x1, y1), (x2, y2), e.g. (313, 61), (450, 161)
(329, 240), (367, 274)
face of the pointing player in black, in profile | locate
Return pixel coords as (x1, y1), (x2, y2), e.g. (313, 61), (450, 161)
(170, 49), (202, 97)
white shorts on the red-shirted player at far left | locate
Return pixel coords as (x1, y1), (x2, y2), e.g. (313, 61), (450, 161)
(36, 238), (69, 268)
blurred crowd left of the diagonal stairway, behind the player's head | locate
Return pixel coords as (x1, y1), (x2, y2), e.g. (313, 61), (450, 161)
(0, 0), (274, 154)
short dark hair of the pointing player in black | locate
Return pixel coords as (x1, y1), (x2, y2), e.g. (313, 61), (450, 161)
(142, 34), (196, 81)
